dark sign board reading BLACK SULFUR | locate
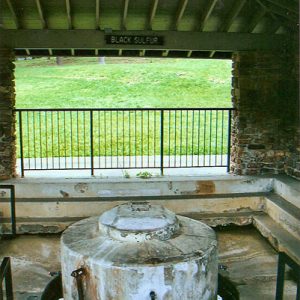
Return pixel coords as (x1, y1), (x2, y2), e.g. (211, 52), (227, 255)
(105, 34), (164, 46)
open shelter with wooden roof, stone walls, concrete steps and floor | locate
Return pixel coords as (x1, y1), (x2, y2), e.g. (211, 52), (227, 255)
(0, 0), (300, 299)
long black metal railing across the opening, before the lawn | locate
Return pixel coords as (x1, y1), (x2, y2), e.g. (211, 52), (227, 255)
(16, 108), (232, 176)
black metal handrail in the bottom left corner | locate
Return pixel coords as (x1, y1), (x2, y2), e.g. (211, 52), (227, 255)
(0, 257), (14, 300)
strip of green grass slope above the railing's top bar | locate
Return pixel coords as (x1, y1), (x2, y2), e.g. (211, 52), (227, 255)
(16, 58), (231, 108)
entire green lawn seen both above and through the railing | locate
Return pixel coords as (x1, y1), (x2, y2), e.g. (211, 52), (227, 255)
(16, 58), (231, 161)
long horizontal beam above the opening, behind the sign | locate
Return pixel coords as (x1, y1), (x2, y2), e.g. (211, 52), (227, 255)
(0, 29), (290, 51)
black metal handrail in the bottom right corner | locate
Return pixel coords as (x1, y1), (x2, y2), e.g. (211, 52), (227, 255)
(275, 252), (300, 300)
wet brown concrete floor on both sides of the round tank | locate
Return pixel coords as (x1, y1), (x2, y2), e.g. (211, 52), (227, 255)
(0, 227), (296, 300)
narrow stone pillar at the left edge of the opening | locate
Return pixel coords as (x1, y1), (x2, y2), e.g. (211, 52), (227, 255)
(0, 49), (16, 180)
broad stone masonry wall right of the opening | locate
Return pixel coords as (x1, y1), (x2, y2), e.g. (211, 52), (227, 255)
(231, 52), (300, 177)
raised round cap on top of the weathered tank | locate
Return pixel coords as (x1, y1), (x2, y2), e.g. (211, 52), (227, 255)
(99, 202), (179, 242)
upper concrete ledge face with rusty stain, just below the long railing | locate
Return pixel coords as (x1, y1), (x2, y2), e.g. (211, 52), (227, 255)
(0, 175), (273, 199)
